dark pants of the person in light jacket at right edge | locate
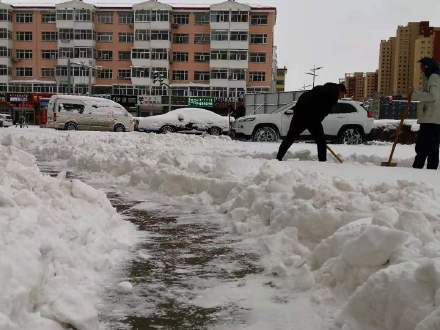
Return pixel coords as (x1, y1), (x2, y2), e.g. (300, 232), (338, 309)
(413, 124), (440, 170)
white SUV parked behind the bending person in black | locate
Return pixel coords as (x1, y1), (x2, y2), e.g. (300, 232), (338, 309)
(233, 100), (374, 144)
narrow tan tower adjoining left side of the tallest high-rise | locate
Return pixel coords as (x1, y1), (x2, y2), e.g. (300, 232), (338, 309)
(378, 37), (396, 96)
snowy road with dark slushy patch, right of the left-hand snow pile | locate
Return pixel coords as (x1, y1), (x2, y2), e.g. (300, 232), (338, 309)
(0, 129), (440, 330)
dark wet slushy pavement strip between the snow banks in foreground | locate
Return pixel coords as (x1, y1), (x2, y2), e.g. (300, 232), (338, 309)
(40, 164), (263, 330)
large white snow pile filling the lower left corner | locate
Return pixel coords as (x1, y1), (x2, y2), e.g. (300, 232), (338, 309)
(0, 144), (137, 330)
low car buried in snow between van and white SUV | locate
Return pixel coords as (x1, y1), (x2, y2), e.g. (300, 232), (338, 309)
(137, 108), (233, 135)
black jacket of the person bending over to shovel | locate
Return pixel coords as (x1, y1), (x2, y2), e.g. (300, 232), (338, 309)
(295, 83), (339, 122)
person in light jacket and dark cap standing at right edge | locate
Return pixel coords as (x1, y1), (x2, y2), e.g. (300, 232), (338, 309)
(412, 57), (440, 170)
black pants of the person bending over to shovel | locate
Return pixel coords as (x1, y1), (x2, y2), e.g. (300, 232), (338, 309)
(277, 116), (327, 162)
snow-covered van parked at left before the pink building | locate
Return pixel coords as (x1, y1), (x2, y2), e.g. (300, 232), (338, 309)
(47, 95), (136, 132)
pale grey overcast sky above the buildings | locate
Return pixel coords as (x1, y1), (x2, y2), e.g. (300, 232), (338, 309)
(12, 0), (440, 90)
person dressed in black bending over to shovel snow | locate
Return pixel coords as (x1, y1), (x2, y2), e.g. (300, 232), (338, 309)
(277, 83), (347, 162)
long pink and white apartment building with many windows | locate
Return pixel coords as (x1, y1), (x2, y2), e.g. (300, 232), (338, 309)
(0, 0), (276, 109)
